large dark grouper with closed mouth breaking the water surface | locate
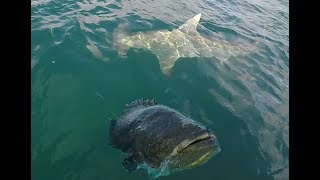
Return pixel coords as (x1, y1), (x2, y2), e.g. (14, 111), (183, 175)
(109, 100), (221, 178)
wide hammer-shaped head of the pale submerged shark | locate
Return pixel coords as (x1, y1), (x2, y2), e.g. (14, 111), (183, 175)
(112, 23), (129, 56)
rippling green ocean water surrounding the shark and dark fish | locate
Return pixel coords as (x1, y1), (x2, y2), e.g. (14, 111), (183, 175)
(30, 0), (289, 180)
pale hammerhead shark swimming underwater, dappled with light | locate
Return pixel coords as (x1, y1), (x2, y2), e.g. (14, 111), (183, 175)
(113, 13), (256, 75)
